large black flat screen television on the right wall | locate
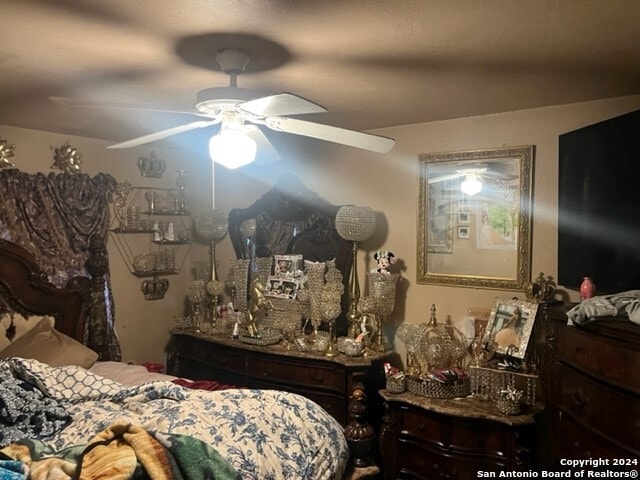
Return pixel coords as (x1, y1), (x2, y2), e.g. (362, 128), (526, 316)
(557, 110), (640, 295)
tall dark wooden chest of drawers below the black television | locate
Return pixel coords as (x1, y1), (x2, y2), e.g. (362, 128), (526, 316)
(540, 305), (640, 469)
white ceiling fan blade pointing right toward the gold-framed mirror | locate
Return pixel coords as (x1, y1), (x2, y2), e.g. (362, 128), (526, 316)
(265, 117), (396, 153)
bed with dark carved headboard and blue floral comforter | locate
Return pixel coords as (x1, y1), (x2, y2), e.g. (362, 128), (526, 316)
(0, 241), (349, 479)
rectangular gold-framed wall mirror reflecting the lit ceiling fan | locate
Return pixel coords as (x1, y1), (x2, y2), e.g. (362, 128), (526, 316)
(417, 145), (534, 290)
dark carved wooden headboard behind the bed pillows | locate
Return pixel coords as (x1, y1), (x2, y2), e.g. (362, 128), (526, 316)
(0, 240), (89, 342)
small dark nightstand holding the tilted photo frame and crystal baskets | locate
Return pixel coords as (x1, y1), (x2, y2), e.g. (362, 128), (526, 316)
(379, 390), (542, 480)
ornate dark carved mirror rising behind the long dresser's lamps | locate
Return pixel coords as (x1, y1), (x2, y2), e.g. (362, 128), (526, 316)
(229, 174), (352, 334)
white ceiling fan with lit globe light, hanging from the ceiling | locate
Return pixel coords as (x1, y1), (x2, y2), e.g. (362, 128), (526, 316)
(54, 49), (395, 168)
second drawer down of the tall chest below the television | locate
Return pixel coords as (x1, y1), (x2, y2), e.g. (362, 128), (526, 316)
(558, 364), (640, 451)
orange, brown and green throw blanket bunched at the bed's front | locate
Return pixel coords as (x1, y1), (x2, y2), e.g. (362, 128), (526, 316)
(0, 421), (239, 480)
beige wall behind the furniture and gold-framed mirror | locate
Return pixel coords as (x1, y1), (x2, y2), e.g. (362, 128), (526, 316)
(0, 96), (640, 362)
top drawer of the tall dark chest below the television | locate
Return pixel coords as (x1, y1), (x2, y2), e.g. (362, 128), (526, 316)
(557, 320), (640, 392)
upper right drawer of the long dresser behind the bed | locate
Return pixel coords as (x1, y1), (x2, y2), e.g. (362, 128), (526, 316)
(246, 356), (347, 392)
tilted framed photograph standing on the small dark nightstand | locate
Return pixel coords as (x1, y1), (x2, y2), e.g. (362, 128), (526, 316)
(482, 299), (538, 360)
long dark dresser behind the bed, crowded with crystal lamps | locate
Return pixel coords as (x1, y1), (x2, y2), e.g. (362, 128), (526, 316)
(167, 330), (385, 425)
